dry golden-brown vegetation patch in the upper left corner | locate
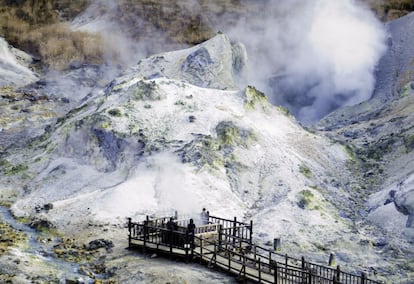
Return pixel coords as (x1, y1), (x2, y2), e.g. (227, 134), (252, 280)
(0, 0), (97, 69)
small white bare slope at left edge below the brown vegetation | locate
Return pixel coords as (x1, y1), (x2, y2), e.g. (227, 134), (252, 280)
(0, 38), (37, 87)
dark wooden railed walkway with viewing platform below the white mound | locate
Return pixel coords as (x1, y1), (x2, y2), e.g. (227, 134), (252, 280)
(128, 216), (380, 284)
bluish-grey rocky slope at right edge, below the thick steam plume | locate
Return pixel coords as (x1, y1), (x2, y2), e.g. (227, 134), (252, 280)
(317, 13), (414, 266)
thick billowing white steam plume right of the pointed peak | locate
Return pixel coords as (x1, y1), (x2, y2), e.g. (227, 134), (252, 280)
(226, 0), (386, 123)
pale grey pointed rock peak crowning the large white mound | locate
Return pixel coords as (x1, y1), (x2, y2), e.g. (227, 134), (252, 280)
(113, 34), (247, 89)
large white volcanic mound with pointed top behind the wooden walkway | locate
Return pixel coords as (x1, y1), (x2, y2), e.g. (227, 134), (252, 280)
(0, 35), (396, 280)
